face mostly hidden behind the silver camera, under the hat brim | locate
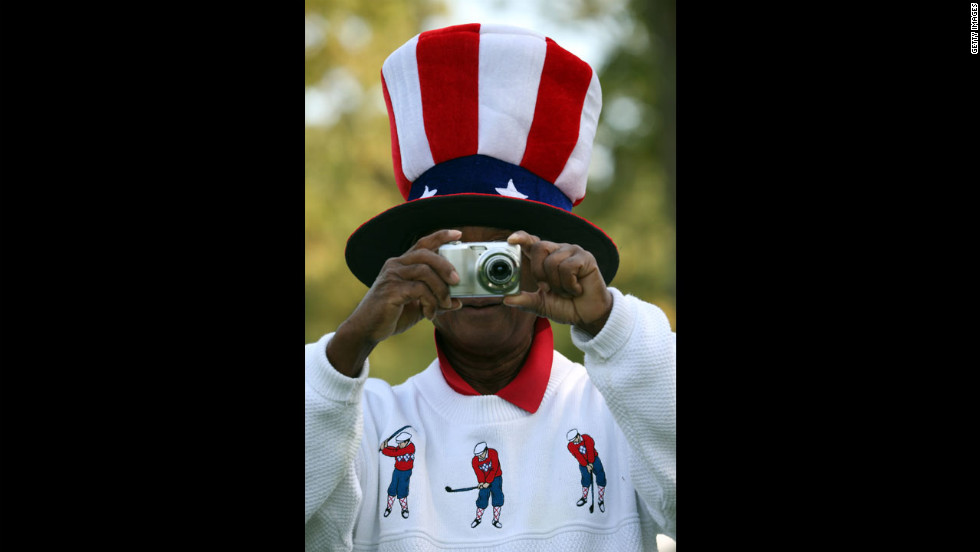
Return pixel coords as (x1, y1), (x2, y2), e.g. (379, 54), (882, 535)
(432, 226), (537, 350)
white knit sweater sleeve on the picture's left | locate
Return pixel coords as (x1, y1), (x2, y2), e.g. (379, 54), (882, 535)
(306, 334), (368, 550)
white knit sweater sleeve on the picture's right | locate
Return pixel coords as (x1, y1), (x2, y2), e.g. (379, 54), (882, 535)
(572, 288), (677, 539)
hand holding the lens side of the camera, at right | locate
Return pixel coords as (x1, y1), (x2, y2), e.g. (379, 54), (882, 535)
(504, 230), (613, 336)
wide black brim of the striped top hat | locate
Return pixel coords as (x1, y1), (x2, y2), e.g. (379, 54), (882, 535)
(345, 194), (619, 287)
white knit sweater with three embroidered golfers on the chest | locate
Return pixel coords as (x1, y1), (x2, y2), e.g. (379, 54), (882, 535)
(306, 288), (676, 552)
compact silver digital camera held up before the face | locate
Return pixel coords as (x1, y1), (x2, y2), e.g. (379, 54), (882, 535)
(439, 242), (521, 297)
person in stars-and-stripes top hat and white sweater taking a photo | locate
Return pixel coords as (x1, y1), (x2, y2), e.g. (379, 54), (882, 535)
(305, 24), (676, 551)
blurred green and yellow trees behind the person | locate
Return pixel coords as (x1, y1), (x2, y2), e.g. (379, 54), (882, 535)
(305, 0), (677, 384)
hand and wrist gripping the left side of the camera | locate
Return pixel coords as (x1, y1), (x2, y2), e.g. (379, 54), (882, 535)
(327, 226), (463, 377)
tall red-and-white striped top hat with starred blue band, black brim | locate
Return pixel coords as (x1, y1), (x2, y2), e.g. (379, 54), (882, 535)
(346, 23), (619, 287)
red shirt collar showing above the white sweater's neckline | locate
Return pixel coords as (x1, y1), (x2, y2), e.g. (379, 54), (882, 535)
(436, 317), (555, 414)
